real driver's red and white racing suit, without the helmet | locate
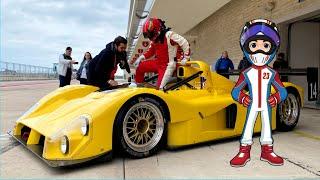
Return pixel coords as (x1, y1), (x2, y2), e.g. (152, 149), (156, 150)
(135, 31), (190, 89)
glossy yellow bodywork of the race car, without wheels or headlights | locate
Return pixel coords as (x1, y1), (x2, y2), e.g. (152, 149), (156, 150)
(14, 61), (303, 160)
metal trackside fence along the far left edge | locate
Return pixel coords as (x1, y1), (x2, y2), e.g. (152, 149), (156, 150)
(0, 61), (57, 81)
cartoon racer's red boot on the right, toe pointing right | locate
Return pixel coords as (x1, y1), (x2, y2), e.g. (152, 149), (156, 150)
(260, 144), (283, 166)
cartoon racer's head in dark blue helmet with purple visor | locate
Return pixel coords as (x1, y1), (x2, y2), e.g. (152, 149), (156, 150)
(240, 19), (280, 66)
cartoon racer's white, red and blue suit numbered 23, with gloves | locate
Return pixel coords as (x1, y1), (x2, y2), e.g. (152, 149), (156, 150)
(231, 65), (287, 145)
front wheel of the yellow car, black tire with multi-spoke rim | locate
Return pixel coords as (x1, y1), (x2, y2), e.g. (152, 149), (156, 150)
(114, 97), (167, 158)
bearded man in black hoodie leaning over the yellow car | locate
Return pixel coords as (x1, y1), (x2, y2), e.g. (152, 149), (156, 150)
(87, 36), (128, 90)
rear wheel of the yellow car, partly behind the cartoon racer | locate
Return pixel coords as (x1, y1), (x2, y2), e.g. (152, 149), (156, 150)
(277, 89), (301, 131)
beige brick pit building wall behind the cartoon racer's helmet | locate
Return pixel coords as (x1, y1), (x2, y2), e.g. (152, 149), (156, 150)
(185, 0), (320, 67)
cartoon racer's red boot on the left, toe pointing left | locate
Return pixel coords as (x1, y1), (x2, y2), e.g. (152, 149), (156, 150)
(230, 145), (251, 167)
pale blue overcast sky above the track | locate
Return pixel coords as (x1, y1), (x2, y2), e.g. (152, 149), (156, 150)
(1, 0), (130, 70)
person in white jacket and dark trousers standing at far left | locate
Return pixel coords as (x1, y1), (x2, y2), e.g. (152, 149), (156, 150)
(58, 47), (78, 87)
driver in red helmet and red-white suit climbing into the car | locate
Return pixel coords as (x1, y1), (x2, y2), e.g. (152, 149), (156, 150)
(130, 18), (190, 89)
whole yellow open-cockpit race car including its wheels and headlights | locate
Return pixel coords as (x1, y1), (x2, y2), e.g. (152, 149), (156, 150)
(11, 61), (303, 167)
